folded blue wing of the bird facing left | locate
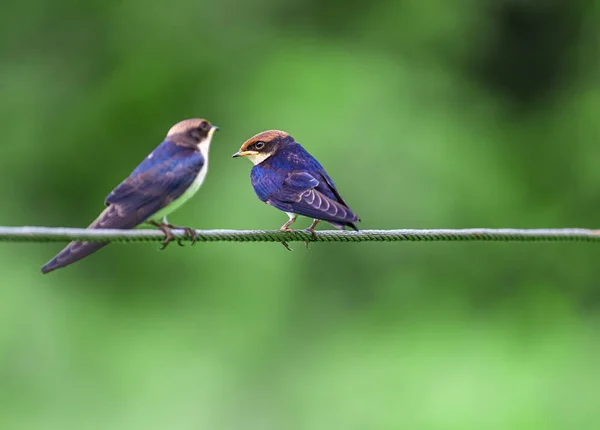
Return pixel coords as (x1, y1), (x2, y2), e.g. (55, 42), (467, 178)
(257, 171), (358, 223)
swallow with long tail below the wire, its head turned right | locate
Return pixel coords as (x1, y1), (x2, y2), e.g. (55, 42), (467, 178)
(42, 119), (219, 273)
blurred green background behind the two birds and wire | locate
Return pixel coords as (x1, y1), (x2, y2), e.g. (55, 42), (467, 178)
(0, 0), (600, 430)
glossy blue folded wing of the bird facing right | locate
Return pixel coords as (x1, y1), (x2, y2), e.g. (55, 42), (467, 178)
(106, 141), (205, 225)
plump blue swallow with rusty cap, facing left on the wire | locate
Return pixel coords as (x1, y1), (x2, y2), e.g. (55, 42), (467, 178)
(233, 130), (360, 249)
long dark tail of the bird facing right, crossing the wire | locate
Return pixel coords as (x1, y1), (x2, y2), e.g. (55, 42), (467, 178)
(42, 205), (136, 273)
